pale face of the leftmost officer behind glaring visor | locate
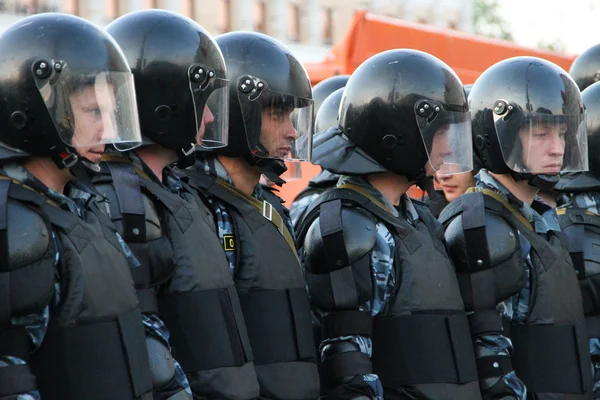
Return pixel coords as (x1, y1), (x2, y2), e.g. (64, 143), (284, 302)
(70, 84), (115, 163)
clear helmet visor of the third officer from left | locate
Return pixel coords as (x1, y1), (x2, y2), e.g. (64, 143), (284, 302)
(238, 76), (313, 161)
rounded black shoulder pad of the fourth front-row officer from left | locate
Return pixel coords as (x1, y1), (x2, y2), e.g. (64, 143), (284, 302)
(304, 207), (377, 274)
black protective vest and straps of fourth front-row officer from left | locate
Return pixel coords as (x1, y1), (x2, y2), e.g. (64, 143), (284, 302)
(298, 184), (481, 400)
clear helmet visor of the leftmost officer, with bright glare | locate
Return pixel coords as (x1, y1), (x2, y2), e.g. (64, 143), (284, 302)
(33, 61), (142, 151)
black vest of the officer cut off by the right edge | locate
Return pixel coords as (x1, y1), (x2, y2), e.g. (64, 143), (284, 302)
(556, 208), (600, 338)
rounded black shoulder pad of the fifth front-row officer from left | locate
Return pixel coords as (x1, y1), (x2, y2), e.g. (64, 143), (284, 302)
(444, 212), (520, 271)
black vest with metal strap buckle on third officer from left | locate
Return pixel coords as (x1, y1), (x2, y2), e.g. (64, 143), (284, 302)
(185, 170), (319, 400)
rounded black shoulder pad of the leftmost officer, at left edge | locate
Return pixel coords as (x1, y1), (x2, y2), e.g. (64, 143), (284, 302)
(6, 199), (50, 270)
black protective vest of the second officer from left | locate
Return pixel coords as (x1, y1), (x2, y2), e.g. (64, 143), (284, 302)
(95, 159), (259, 400)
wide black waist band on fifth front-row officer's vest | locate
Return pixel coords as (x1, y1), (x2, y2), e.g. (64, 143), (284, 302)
(511, 324), (590, 393)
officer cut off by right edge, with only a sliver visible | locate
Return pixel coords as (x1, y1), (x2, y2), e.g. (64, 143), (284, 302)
(556, 79), (600, 399)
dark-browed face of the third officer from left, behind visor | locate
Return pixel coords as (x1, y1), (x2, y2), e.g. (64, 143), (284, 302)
(260, 107), (298, 158)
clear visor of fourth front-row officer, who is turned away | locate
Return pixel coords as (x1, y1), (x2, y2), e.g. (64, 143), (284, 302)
(415, 100), (473, 175)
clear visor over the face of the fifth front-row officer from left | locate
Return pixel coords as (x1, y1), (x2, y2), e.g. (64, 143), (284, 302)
(494, 106), (588, 175)
